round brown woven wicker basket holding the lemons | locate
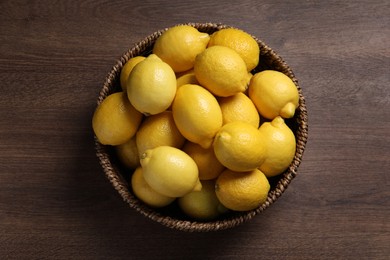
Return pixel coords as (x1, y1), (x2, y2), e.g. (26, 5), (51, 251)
(95, 23), (308, 232)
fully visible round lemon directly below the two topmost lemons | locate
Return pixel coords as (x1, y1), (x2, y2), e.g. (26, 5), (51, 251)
(194, 46), (248, 97)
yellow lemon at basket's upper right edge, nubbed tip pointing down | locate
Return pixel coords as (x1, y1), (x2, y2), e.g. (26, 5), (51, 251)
(248, 70), (299, 119)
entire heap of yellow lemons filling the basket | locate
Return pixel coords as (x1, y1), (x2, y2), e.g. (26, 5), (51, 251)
(92, 25), (299, 220)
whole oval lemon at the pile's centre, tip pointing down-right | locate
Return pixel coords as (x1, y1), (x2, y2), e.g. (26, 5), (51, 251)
(172, 84), (222, 148)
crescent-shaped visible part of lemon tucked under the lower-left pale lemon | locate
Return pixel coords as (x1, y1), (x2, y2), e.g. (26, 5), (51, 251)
(131, 167), (175, 208)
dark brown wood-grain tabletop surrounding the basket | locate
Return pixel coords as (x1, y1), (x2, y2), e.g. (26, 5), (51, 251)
(0, 0), (390, 259)
